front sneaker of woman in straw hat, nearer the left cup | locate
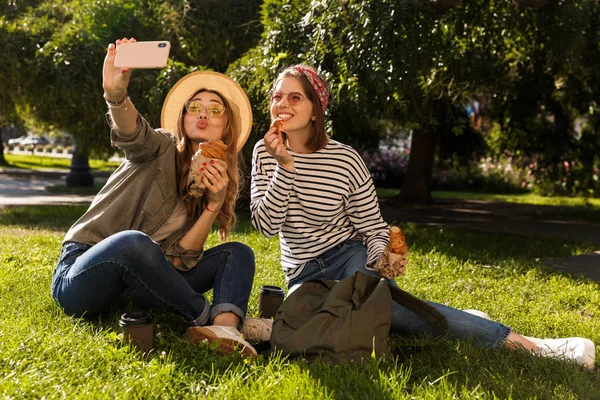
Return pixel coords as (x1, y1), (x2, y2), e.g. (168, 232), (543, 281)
(185, 325), (258, 357)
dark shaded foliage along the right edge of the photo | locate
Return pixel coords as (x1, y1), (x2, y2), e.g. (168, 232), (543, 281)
(489, 0), (600, 196)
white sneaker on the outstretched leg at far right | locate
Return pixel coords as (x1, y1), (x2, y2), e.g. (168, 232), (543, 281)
(536, 337), (596, 369)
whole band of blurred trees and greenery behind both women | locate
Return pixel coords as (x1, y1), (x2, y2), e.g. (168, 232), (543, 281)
(0, 0), (600, 203)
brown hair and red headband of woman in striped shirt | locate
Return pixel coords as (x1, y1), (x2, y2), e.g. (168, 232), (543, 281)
(271, 64), (329, 151)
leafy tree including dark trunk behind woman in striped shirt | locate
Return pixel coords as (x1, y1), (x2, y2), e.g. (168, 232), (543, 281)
(230, 0), (514, 203)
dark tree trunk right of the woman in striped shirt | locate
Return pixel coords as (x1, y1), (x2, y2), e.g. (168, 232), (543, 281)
(396, 100), (447, 205)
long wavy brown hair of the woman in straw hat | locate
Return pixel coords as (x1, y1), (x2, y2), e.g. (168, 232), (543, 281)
(175, 89), (240, 241)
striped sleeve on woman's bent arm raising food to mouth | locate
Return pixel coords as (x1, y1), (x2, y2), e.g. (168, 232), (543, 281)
(250, 140), (296, 238)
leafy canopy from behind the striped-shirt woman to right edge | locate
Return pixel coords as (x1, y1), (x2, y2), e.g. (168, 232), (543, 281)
(229, 0), (600, 200)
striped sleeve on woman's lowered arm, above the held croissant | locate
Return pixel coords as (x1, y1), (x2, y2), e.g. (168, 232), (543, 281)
(346, 155), (390, 266)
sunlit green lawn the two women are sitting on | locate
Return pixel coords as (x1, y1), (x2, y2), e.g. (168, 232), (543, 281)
(0, 206), (600, 399)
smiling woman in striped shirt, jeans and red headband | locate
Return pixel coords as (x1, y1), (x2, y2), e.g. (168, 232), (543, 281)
(251, 65), (595, 368)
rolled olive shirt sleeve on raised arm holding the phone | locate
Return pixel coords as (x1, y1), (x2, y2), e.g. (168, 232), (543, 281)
(110, 114), (175, 163)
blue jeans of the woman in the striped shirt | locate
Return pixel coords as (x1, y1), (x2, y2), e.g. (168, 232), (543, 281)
(288, 240), (512, 348)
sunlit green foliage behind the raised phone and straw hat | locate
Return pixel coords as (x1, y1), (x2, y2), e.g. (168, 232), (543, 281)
(0, 0), (259, 157)
